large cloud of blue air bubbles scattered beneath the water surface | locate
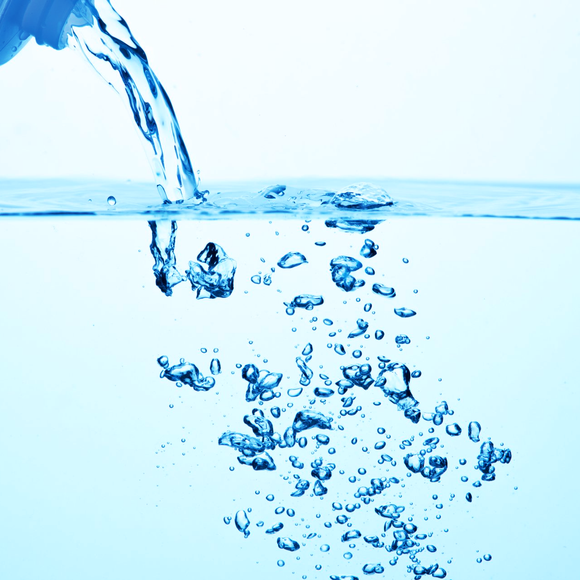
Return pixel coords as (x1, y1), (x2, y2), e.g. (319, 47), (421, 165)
(158, 220), (512, 580)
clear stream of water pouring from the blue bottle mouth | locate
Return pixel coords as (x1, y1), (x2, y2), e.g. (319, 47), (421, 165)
(68, 0), (203, 203)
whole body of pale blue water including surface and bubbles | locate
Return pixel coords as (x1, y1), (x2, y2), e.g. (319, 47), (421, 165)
(0, 183), (580, 580)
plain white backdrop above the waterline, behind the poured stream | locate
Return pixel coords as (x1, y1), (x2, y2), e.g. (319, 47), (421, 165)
(0, 0), (580, 182)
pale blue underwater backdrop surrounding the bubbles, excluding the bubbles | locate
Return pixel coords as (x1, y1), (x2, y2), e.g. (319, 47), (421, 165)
(0, 218), (580, 580)
